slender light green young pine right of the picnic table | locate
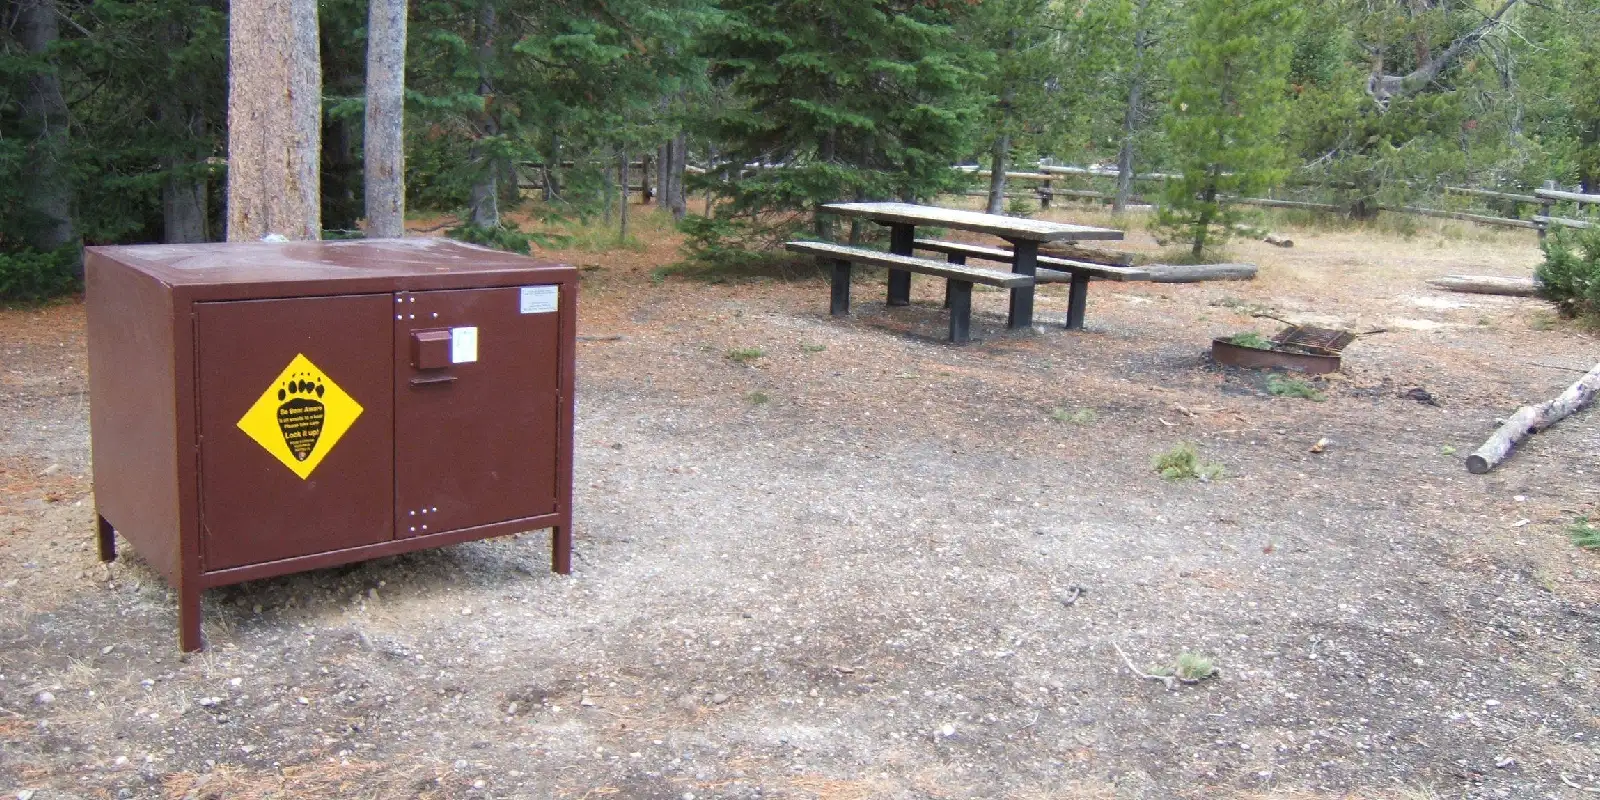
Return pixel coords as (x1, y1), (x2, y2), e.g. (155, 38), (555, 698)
(1158, 0), (1299, 258)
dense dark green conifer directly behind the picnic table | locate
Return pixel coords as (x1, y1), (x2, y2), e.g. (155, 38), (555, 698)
(702, 0), (982, 246)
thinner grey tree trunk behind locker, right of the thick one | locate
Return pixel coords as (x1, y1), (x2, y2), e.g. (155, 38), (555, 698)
(363, 0), (406, 238)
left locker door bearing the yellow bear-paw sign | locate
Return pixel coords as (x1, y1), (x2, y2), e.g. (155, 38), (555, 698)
(195, 294), (395, 571)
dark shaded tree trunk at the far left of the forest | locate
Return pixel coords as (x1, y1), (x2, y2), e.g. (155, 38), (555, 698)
(16, 0), (83, 264)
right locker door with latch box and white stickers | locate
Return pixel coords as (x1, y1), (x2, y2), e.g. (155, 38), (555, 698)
(394, 286), (560, 538)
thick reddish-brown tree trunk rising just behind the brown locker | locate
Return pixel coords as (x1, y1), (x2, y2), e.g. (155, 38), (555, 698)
(227, 0), (322, 242)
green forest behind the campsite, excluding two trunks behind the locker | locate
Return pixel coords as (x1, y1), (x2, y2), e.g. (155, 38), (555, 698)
(0, 0), (1600, 299)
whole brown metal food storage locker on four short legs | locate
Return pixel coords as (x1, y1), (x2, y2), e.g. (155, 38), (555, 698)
(86, 238), (578, 650)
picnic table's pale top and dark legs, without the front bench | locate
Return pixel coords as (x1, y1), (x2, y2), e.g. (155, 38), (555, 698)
(800, 203), (1122, 341)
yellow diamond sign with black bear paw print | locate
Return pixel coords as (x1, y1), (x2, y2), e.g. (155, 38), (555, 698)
(238, 354), (362, 480)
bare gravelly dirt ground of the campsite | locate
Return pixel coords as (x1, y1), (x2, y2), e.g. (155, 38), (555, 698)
(0, 203), (1600, 800)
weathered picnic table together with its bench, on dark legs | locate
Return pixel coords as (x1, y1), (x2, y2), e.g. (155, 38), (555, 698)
(787, 203), (1122, 342)
